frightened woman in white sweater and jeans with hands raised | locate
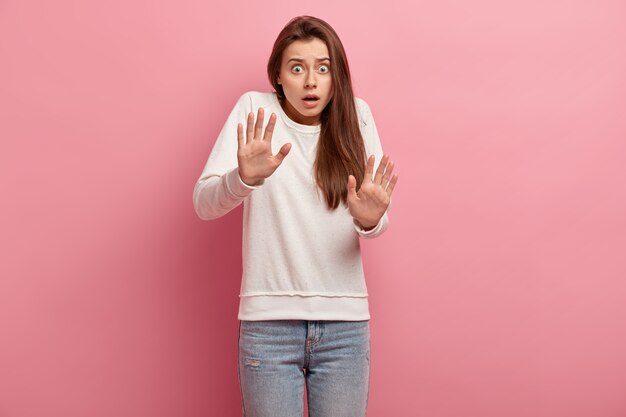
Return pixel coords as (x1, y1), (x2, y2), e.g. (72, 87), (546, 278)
(193, 16), (398, 417)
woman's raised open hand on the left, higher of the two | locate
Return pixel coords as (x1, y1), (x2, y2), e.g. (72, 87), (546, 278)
(237, 107), (291, 186)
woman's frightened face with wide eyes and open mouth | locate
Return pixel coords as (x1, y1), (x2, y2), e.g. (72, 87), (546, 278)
(278, 38), (333, 125)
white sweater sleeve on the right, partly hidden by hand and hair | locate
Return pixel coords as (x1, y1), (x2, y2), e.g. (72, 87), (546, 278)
(354, 98), (391, 239)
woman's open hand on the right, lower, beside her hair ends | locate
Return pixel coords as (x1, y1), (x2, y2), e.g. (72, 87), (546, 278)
(348, 155), (398, 229)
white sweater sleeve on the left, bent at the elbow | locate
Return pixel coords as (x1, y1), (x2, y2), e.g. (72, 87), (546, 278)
(193, 93), (264, 220)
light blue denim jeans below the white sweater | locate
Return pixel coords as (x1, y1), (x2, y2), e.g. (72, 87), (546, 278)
(237, 320), (370, 417)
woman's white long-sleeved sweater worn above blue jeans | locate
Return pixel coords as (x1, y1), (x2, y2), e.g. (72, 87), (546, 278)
(193, 91), (389, 321)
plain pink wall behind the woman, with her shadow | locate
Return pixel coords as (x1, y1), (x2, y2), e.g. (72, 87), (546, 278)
(0, 0), (626, 417)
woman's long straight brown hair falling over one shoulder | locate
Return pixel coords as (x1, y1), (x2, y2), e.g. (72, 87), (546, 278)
(267, 16), (366, 210)
